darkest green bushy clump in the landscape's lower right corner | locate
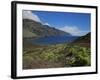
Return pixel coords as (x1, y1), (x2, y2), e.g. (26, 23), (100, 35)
(67, 46), (90, 66)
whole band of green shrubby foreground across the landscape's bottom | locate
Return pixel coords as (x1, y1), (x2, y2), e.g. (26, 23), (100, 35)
(23, 44), (91, 69)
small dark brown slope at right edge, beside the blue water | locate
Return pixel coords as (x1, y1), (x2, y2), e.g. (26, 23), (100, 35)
(73, 32), (91, 47)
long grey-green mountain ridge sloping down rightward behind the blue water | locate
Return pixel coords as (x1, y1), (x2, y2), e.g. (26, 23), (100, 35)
(23, 19), (70, 38)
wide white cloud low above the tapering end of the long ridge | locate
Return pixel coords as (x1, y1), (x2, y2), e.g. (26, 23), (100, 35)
(59, 26), (89, 36)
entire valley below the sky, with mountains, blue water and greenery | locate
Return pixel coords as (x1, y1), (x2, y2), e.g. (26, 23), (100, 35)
(23, 19), (91, 69)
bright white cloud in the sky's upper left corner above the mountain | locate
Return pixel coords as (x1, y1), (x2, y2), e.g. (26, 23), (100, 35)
(22, 11), (41, 22)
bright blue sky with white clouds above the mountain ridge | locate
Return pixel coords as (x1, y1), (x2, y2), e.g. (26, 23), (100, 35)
(23, 10), (91, 36)
